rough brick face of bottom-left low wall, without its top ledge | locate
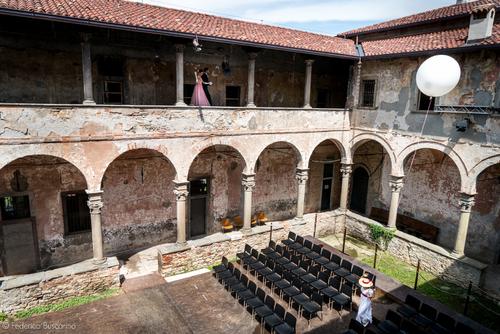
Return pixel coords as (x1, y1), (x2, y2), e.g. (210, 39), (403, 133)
(0, 266), (119, 314)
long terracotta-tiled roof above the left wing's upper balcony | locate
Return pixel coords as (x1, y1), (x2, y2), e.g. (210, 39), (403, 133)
(0, 0), (356, 56)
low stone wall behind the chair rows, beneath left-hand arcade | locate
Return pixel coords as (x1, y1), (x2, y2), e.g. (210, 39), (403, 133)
(162, 211), (344, 276)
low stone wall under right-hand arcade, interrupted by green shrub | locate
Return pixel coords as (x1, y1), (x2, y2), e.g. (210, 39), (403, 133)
(345, 213), (486, 287)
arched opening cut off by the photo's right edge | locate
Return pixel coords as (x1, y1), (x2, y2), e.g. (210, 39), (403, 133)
(465, 164), (500, 265)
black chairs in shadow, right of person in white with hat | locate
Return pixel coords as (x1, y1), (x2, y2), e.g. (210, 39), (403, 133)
(394, 295), (475, 334)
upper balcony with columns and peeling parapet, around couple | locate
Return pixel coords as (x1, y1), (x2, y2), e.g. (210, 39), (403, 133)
(0, 17), (351, 141)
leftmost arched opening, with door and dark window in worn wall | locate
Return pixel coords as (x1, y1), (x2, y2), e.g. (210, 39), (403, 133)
(0, 155), (88, 276)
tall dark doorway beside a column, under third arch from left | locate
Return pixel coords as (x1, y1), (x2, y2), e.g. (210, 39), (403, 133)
(189, 178), (209, 237)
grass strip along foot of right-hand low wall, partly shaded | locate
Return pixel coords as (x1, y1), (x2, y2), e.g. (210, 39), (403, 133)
(361, 252), (500, 331)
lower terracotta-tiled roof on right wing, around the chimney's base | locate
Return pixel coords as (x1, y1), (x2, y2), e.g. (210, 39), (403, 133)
(362, 24), (500, 57)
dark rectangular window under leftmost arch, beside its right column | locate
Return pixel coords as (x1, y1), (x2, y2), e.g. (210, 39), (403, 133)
(62, 191), (90, 234)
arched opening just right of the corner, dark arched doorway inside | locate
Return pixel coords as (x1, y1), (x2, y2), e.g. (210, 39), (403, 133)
(349, 140), (391, 215)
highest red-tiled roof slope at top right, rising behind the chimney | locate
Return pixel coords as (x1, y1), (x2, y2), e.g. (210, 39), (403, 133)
(338, 0), (500, 36)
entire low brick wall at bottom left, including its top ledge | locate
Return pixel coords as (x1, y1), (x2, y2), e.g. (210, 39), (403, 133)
(0, 258), (120, 314)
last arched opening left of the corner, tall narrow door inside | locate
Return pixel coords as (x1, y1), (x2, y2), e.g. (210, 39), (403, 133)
(305, 140), (341, 213)
